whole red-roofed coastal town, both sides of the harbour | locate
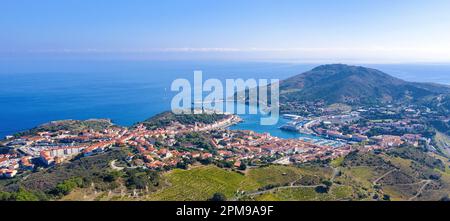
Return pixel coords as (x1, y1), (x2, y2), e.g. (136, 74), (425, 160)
(0, 100), (435, 178)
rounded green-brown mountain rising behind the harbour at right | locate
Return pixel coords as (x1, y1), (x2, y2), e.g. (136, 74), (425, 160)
(280, 64), (450, 104)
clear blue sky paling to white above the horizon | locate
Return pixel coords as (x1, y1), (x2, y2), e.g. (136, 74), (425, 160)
(0, 0), (450, 63)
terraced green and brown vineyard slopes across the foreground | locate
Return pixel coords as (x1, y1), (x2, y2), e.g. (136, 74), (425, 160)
(42, 149), (450, 201)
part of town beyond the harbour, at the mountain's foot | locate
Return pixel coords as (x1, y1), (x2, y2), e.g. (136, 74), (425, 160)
(280, 105), (434, 148)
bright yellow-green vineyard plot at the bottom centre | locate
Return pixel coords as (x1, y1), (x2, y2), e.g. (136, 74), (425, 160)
(146, 165), (338, 200)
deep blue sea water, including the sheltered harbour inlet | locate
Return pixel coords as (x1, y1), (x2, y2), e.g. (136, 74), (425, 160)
(0, 60), (450, 138)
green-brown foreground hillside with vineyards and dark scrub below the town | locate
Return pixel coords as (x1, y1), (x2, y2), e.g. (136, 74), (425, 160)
(9, 147), (442, 201)
